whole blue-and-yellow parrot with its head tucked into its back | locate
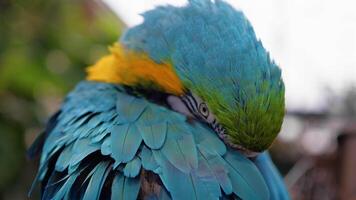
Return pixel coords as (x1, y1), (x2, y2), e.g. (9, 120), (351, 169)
(28, 0), (289, 200)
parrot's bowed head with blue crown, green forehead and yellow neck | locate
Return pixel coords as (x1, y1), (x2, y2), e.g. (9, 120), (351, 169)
(89, 0), (285, 154)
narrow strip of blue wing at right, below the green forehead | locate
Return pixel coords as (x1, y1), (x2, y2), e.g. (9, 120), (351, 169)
(255, 152), (290, 200)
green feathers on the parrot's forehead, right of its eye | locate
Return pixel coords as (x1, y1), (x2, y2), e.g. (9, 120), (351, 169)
(193, 79), (285, 152)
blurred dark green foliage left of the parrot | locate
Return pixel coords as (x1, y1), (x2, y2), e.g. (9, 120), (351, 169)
(0, 0), (124, 199)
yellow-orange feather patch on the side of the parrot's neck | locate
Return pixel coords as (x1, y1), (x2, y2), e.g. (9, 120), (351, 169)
(87, 43), (184, 95)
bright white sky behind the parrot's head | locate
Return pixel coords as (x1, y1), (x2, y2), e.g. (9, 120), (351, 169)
(103, 0), (356, 110)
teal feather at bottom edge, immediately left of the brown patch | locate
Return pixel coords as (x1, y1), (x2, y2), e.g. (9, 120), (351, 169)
(111, 173), (140, 200)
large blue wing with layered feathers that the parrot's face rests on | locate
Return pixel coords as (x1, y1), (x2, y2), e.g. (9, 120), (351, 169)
(30, 81), (269, 200)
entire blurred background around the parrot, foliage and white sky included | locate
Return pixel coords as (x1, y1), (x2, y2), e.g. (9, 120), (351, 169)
(0, 0), (356, 200)
